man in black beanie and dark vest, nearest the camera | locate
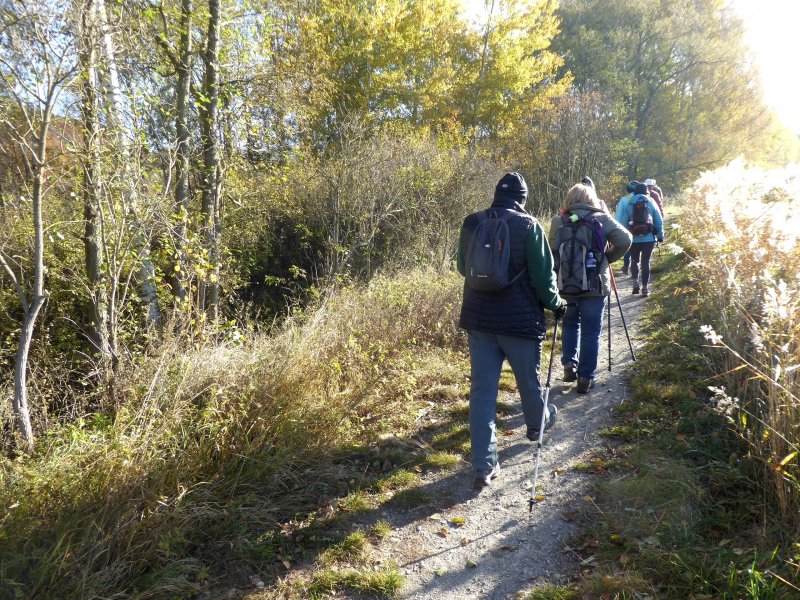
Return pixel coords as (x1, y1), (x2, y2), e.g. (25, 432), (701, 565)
(457, 173), (566, 490)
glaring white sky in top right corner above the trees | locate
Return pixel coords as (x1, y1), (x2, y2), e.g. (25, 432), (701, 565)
(462, 0), (800, 134)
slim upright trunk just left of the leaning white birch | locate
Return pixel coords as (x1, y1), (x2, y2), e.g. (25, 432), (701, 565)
(80, 0), (113, 371)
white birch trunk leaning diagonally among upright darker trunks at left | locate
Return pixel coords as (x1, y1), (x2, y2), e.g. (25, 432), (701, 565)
(97, 0), (161, 325)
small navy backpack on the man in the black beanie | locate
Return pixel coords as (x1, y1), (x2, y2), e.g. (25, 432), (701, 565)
(464, 209), (525, 292)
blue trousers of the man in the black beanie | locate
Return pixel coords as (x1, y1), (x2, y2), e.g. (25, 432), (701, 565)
(468, 331), (542, 474)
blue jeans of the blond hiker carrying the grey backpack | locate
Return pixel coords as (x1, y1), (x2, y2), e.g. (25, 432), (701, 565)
(561, 296), (606, 379)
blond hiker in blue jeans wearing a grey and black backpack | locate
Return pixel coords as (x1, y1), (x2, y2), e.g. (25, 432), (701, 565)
(548, 183), (631, 394)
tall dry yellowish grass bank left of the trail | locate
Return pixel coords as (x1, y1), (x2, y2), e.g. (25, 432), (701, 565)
(0, 270), (463, 598)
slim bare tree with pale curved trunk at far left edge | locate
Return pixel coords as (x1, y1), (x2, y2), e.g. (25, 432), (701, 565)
(0, 0), (77, 450)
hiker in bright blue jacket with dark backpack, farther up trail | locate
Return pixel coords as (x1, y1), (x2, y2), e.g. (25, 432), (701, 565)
(620, 183), (664, 296)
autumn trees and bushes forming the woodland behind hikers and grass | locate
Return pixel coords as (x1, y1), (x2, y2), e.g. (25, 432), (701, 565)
(0, 0), (800, 596)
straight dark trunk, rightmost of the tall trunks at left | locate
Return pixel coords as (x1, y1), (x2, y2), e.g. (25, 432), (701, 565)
(201, 0), (220, 317)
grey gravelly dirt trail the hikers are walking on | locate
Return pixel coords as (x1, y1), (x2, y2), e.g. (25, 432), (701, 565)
(379, 276), (644, 600)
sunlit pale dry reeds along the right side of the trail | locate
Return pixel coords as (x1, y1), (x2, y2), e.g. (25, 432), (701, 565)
(681, 161), (800, 527)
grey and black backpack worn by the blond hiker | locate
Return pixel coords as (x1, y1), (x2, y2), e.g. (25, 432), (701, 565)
(553, 213), (606, 296)
